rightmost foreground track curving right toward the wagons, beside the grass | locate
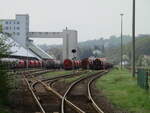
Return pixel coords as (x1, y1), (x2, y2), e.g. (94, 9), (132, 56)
(61, 72), (106, 113)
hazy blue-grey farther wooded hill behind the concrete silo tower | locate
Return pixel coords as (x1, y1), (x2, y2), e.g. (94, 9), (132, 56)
(39, 35), (132, 59)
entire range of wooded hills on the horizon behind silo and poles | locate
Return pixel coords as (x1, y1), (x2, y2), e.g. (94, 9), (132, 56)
(40, 35), (150, 64)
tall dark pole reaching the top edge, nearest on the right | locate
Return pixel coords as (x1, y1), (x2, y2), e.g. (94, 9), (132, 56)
(132, 0), (135, 77)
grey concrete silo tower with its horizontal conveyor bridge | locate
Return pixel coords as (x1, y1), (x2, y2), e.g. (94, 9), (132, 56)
(28, 29), (78, 60)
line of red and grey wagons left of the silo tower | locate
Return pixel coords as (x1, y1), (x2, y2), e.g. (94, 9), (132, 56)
(0, 58), (62, 69)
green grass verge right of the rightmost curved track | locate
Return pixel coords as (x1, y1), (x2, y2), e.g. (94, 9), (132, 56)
(96, 69), (150, 113)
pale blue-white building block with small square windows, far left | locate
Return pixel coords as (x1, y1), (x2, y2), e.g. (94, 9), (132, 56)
(1, 15), (29, 47)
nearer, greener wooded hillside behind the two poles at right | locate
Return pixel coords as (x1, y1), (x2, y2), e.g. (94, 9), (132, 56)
(105, 37), (150, 66)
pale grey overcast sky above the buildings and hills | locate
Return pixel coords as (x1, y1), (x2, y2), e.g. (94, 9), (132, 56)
(0, 0), (150, 44)
